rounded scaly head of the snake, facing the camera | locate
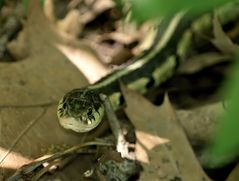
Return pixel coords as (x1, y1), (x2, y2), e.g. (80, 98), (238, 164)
(57, 89), (104, 133)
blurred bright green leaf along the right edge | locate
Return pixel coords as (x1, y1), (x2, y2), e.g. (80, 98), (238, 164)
(209, 57), (239, 157)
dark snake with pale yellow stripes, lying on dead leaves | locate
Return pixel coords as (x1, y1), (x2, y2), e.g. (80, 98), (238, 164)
(57, 2), (239, 133)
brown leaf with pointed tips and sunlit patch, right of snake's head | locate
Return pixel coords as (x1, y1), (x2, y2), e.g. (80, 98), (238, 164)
(122, 87), (210, 181)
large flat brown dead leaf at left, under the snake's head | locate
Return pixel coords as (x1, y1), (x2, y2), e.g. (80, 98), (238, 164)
(0, 1), (103, 180)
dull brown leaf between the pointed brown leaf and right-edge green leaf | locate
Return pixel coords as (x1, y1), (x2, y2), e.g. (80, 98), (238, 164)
(176, 102), (225, 148)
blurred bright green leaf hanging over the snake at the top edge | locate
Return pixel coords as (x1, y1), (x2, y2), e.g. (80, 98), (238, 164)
(130, 0), (228, 21)
